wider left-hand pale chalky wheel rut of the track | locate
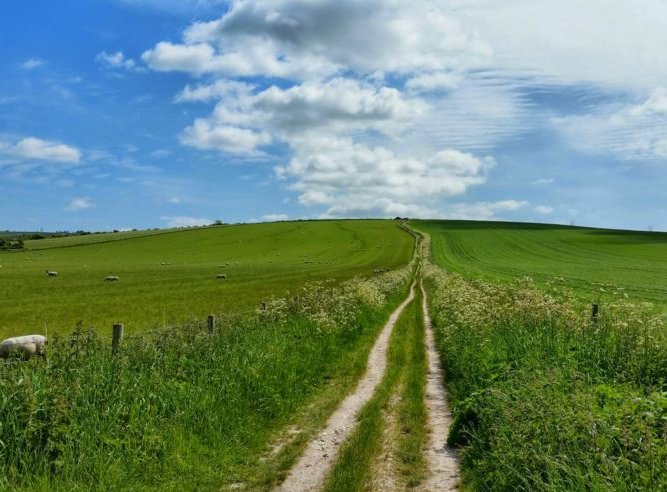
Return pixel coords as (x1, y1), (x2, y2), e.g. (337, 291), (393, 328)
(277, 283), (415, 492)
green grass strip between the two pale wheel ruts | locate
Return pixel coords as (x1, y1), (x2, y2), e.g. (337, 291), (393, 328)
(325, 284), (426, 491)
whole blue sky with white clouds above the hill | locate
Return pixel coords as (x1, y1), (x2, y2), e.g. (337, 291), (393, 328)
(0, 0), (667, 230)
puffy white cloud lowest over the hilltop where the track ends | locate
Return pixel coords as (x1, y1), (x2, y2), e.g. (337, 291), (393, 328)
(276, 137), (495, 217)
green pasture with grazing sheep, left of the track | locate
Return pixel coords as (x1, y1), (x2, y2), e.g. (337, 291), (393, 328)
(0, 220), (412, 338)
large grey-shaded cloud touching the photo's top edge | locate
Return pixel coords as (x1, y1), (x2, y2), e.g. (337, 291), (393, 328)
(142, 0), (490, 79)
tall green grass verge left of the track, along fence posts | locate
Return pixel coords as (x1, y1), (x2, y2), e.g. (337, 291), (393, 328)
(0, 266), (412, 490)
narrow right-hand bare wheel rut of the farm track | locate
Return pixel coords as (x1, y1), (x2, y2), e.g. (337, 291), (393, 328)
(419, 281), (459, 491)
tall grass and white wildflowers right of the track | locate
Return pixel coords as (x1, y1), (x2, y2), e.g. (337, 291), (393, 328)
(427, 260), (667, 490)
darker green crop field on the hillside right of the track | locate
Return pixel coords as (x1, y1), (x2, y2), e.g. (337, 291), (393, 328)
(410, 220), (667, 304)
